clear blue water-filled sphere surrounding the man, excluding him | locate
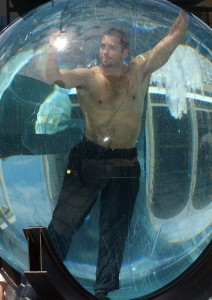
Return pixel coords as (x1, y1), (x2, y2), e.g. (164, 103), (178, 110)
(0, 0), (212, 300)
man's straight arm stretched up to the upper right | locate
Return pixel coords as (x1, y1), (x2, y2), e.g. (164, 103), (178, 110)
(133, 10), (188, 74)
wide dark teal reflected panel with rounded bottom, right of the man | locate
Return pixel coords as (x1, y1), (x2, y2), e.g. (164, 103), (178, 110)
(152, 104), (192, 219)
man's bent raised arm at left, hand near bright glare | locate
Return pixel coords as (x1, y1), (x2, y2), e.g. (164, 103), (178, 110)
(45, 32), (89, 88)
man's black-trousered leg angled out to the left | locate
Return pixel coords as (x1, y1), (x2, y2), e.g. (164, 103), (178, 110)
(48, 168), (99, 260)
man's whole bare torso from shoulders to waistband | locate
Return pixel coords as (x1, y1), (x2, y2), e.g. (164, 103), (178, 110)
(77, 64), (149, 149)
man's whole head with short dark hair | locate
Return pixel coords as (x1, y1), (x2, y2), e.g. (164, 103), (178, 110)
(99, 28), (129, 68)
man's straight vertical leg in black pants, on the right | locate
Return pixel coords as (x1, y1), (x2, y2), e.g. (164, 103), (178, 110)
(94, 165), (140, 296)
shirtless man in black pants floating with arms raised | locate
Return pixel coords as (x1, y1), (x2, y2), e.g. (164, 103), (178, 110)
(46, 11), (188, 299)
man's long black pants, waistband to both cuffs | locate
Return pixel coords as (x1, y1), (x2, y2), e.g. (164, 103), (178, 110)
(48, 138), (140, 292)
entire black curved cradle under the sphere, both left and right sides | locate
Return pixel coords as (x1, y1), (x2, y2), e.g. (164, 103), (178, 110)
(24, 227), (212, 300)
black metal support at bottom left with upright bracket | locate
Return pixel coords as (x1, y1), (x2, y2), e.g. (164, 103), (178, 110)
(24, 227), (96, 300)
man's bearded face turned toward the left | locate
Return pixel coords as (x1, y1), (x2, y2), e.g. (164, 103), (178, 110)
(99, 35), (128, 68)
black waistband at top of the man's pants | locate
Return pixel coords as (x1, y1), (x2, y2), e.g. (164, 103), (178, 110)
(81, 137), (137, 159)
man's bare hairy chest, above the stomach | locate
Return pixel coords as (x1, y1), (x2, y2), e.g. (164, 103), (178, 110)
(78, 70), (148, 123)
